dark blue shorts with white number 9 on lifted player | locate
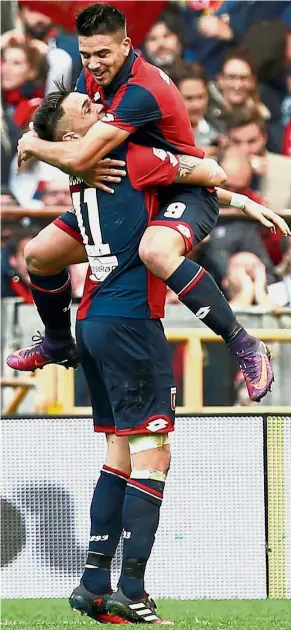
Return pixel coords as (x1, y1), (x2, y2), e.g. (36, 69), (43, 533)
(149, 185), (219, 254)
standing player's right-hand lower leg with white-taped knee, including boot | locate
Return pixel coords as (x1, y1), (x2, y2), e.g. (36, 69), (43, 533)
(106, 435), (171, 624)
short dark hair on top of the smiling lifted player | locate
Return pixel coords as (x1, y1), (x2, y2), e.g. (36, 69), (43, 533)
(76, 2), (126, 37)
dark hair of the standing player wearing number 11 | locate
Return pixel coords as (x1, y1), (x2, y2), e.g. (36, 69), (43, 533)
(33, 81), (71, 142)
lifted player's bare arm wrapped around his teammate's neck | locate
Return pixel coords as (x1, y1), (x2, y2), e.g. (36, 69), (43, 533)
(18, 121), (129, 174)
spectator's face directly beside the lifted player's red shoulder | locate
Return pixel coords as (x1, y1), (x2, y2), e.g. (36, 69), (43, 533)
(178, 79), (208, 127)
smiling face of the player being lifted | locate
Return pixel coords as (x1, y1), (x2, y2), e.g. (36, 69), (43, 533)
(78, 32), (131, 87)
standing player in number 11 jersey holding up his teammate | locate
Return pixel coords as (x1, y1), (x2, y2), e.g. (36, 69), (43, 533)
(12, 82), (286, 623)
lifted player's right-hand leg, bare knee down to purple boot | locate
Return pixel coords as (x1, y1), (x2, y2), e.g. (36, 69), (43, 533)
(140, 226), (274, 401)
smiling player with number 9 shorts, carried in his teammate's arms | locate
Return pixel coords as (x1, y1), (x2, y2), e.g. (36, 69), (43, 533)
(14, 4), (288, 400)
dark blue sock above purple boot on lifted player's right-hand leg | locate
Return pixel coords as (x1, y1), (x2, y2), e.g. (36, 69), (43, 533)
(166, 258), (243, 343)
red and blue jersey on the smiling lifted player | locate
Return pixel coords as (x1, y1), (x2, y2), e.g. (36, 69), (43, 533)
(76, 49), (204, 158)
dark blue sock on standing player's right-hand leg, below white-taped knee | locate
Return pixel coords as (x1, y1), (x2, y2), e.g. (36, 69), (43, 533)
(119, 478), (165, 599)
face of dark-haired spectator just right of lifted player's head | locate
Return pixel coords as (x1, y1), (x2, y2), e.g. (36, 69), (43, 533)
(145, 22), (181, 67)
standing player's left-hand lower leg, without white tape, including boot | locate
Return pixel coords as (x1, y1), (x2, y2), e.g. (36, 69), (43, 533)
(69, 435), (130, 624)
